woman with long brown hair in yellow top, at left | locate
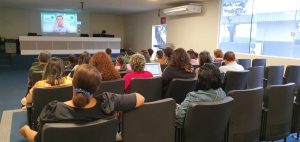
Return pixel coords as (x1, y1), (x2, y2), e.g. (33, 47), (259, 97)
(21, 57), (72, 105)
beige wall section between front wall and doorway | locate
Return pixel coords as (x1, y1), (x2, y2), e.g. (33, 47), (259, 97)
(124, 11), (160, 51)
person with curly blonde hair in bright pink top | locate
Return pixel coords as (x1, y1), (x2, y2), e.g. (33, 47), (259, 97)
(123, 53), (153, 93)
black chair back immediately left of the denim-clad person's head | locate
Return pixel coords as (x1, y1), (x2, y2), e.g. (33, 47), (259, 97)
(165, 78), (196, 104)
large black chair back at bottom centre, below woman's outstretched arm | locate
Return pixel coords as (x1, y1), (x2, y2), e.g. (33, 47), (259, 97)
(122, 98), (176, 142)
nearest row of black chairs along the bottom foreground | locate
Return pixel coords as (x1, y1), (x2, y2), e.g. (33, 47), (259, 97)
(38, 83), (300, 142)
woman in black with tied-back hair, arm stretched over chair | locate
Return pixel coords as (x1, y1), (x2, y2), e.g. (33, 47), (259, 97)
(20, 64), (145, 142)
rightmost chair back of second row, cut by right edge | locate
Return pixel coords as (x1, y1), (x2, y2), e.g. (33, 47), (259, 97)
(284, 65), (300, 88)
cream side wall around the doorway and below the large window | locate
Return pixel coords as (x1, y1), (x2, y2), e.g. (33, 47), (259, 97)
(125, 0), (300, 66)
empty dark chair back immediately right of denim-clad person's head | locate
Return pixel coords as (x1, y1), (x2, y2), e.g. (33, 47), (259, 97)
(223, 70), (249, 93)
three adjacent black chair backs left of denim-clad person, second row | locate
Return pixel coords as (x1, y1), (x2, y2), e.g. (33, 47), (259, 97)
(96, 77), (196, 103)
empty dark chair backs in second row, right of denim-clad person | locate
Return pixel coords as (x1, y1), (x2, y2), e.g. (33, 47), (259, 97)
(223, 65), (300, 92)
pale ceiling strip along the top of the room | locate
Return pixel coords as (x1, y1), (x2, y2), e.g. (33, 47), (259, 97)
(0, 0), (209, 14)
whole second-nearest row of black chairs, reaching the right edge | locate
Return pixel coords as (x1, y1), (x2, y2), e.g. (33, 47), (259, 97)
(29, 65), (300, 103)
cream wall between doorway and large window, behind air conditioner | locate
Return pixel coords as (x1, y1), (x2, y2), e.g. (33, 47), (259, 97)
(167, 0), (219, 52)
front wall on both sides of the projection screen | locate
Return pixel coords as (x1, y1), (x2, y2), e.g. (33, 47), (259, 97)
(0, 8), (124, 47)
